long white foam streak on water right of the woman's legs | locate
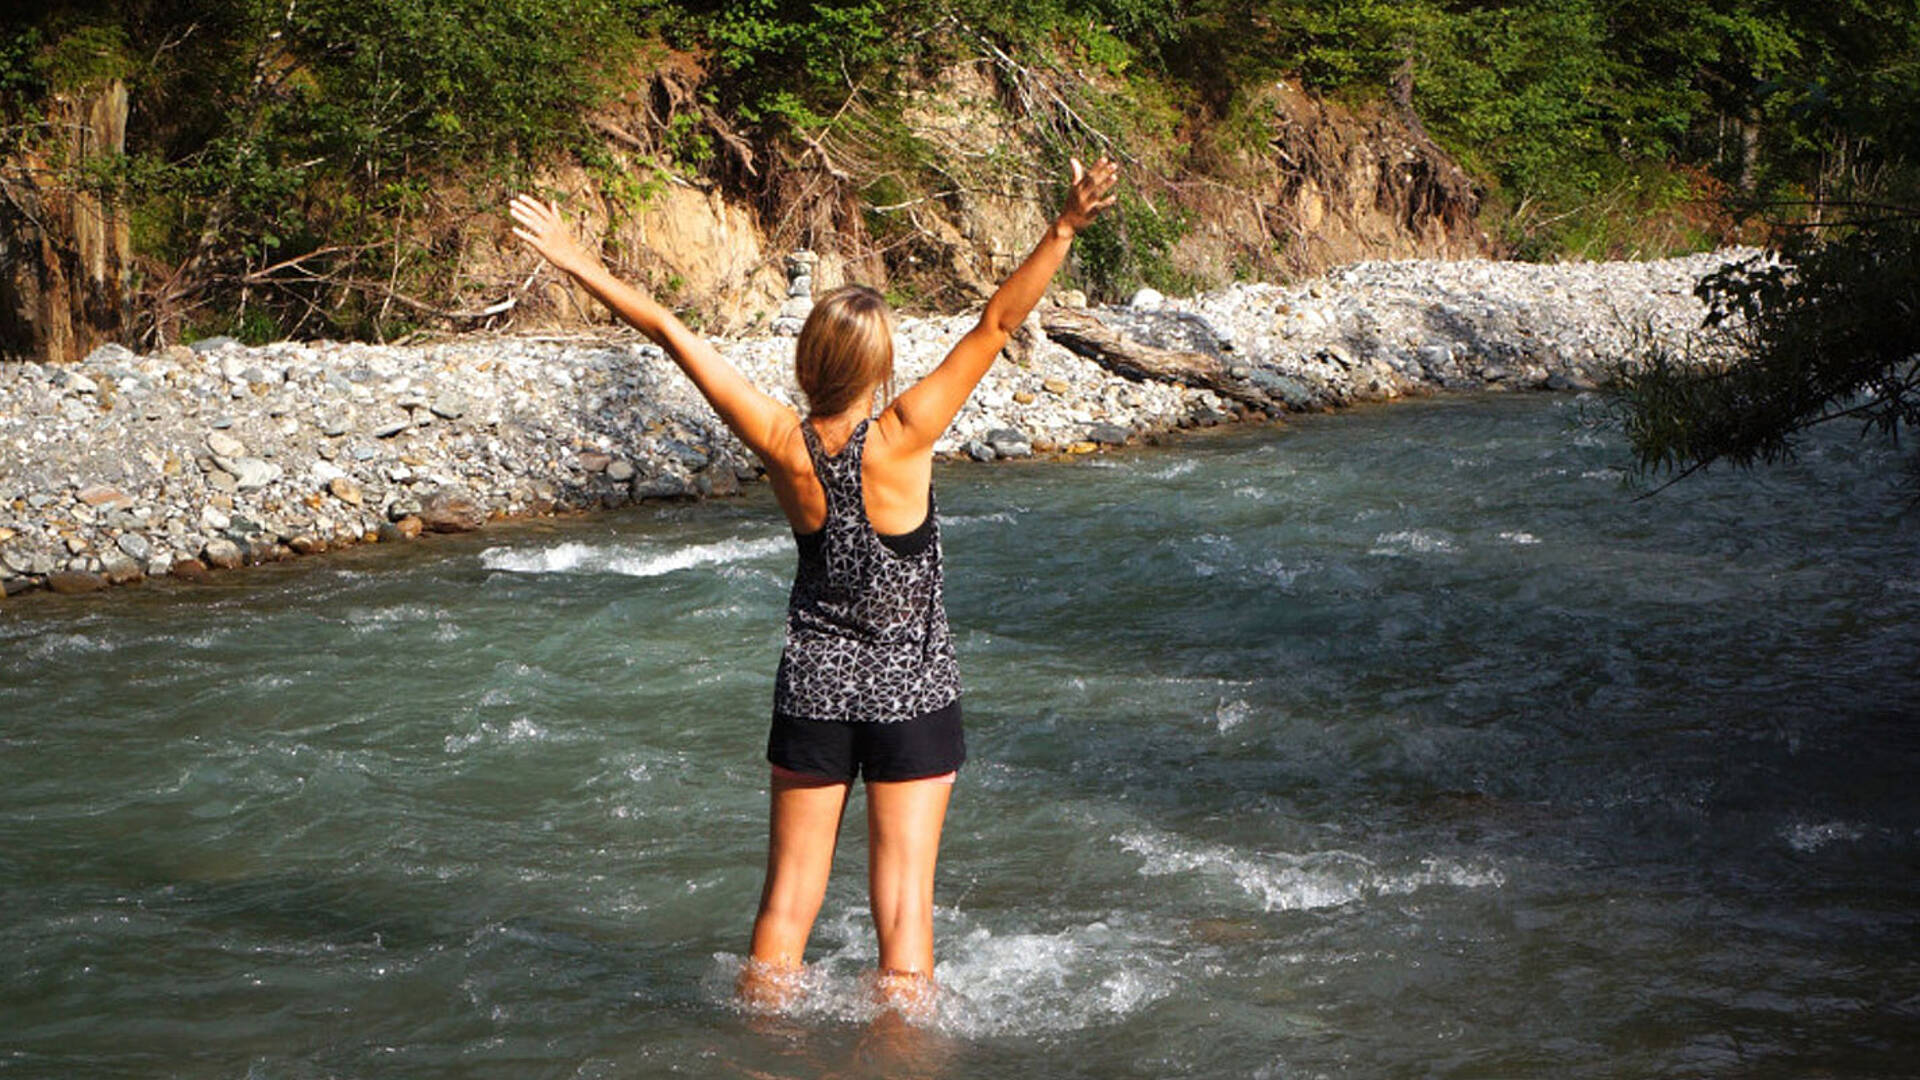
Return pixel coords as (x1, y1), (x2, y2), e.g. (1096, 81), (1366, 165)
(1114, 830), (1507, 911)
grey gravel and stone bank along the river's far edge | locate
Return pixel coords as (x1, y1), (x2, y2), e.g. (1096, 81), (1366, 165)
(0, 252), (1740, 594)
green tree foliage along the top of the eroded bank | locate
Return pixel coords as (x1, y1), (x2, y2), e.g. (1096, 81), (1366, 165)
(0, 0), (1920, 334)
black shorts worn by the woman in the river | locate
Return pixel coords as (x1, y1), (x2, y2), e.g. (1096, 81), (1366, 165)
(766, 698), (966, 782)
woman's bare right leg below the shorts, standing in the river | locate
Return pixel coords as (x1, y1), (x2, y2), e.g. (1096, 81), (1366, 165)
(866, 778), (954, 1005)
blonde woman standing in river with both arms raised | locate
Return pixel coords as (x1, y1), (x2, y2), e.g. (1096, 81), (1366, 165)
(511, 158), (1117, 1007)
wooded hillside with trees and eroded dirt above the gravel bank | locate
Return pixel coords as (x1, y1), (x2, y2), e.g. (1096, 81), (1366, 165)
(0, 0), (1920, 359)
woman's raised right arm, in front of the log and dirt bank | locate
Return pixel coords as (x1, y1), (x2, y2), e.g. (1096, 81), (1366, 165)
(879, 156), (1119, 450)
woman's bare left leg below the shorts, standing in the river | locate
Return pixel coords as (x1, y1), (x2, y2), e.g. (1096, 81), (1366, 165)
(739, 773), (852, 1009)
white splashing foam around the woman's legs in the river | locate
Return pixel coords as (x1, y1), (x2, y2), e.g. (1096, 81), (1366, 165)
(703, 907), (1177, 1038)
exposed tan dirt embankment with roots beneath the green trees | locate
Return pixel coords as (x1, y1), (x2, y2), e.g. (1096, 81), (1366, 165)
(353, 58), (1496, 332)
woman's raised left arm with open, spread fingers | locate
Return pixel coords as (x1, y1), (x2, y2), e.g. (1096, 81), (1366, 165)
(511, 194), (799, 461)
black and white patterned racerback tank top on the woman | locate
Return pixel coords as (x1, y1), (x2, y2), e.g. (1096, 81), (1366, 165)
(774, 421), (960, 723)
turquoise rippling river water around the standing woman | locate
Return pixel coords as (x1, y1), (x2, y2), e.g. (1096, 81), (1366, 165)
(0, 396), (1920, 1078)
